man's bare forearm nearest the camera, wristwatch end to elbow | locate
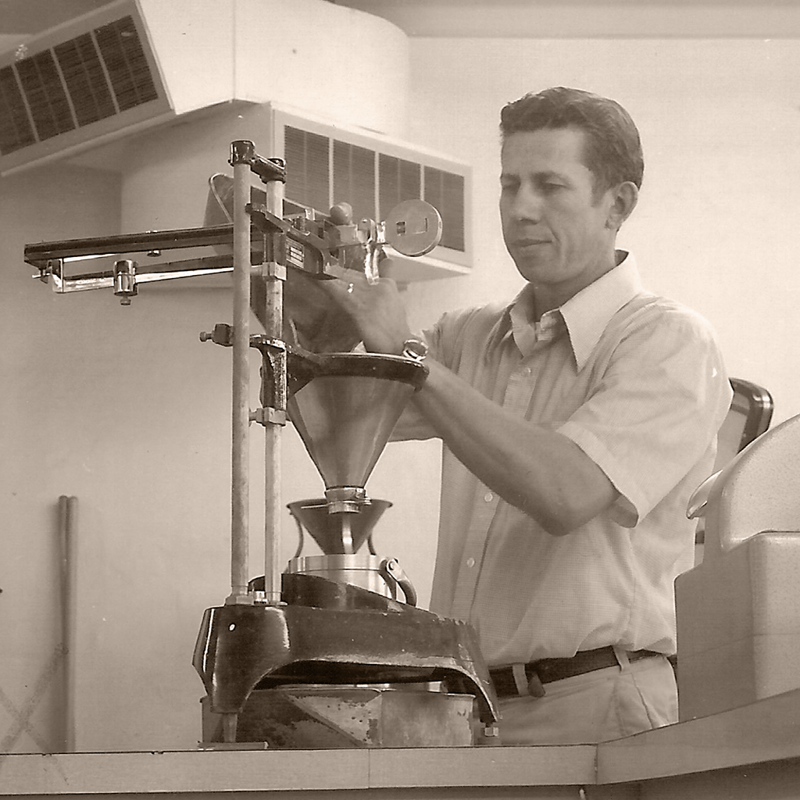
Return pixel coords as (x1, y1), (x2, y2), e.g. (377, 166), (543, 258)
(414, 359), (617, 535)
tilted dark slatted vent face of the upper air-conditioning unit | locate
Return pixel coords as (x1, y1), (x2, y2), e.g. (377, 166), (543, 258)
(0, 0), (174, 173)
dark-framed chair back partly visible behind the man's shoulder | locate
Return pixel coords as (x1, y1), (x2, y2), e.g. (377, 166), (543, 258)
(695, 378), (774, 565)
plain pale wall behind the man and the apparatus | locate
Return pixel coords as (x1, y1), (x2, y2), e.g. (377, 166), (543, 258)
(0, 10), (800, 751)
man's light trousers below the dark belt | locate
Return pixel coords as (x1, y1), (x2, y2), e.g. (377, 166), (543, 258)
(499, 657), (678, 745)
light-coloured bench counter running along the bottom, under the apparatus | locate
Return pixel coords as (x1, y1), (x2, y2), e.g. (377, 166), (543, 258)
(0, 690), (800, 800)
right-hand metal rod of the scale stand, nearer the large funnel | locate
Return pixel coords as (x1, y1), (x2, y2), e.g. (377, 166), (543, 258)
(264, 170), (286, 604)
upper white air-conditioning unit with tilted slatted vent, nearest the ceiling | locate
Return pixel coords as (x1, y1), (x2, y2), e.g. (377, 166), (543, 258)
(0, 0), (408, 174)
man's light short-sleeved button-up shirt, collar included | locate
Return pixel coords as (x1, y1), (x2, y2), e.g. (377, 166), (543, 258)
(394, 254), (731, 666)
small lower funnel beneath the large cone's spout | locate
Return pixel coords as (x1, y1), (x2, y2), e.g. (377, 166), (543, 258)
(288, 500), (392, 555)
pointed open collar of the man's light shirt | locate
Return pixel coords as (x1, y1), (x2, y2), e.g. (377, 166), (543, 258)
(492, 250), (642, 371)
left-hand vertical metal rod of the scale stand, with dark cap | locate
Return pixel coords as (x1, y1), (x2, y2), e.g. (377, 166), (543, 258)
(230, 142), (253, 602)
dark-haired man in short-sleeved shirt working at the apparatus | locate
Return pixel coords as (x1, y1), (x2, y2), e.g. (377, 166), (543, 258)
(304, 88), (731, 744)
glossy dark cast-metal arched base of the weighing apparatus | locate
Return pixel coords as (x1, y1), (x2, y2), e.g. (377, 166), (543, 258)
(193, 574), (499, 728)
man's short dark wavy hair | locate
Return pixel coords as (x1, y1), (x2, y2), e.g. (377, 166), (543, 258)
(500, 86), (644, 195)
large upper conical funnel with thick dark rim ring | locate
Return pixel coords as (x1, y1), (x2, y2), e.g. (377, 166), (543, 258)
(287, 353), (428, 489)
